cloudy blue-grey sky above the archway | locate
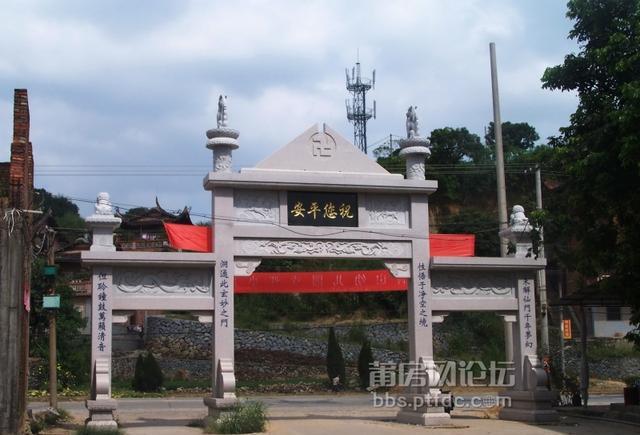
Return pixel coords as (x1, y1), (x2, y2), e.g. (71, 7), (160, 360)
(0, 0), (576, 220)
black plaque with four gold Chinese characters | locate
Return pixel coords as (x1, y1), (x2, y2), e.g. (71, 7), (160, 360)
(287, 192), (358, 227)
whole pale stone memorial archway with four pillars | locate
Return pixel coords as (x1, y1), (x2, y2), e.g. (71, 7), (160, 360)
(82, 103), (555, 426)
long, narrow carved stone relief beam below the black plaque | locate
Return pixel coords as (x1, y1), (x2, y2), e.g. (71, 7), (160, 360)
(234, 240), (411, 258)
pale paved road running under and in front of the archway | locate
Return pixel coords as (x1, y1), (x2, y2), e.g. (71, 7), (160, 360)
(30, 394), (639, 435)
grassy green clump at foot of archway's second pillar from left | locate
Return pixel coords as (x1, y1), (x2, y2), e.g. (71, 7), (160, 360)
(205, 402), (267, 433)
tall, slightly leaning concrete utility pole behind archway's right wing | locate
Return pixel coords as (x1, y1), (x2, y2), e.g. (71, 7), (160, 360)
(489, 42), (513, 361)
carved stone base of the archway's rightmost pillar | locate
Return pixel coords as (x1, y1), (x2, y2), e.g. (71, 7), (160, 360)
(499, 390), (558, 423)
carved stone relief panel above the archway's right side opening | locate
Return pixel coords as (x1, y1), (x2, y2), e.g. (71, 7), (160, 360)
(431, 270), (516, 297)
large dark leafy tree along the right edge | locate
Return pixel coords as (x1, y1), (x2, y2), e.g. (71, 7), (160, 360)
(542, 0), (640, 345)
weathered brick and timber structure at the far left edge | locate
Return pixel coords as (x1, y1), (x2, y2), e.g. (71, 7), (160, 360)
(0, 89), (33, 434)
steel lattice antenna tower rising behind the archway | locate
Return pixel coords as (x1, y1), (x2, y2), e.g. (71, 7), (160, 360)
(345, 61), (376, 154)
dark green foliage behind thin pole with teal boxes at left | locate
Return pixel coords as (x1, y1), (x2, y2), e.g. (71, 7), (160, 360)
(29, 259), (91, 388)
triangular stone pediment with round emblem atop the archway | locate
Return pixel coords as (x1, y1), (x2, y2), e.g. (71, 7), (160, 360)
(255, 124), (392, 175)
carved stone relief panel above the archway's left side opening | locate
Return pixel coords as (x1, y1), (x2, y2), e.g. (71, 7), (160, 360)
(113, 268), (212, 296)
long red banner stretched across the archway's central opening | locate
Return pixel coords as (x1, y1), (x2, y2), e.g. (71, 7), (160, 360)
(234, 269), (409, 294)
